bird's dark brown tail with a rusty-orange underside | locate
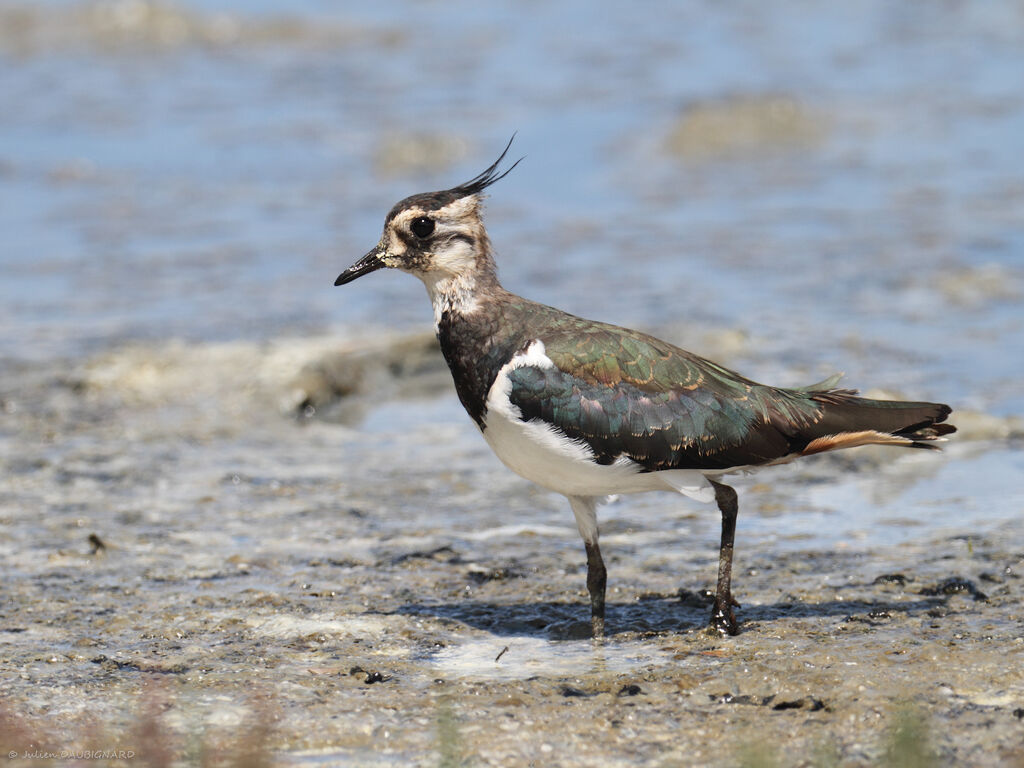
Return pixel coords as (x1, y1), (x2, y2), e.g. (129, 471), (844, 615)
(800, 389), (956, 456)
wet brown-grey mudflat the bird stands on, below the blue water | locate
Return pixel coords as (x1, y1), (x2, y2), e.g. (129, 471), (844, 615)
(0, 344), (1024, 766)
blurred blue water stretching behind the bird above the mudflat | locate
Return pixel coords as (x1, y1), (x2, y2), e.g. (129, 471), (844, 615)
(0, 0), (1024, 414)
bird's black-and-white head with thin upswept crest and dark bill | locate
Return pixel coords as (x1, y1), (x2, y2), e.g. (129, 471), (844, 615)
(334, 136), (521, 287)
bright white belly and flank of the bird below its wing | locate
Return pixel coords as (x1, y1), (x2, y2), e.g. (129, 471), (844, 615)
(483, 339), (715, 501)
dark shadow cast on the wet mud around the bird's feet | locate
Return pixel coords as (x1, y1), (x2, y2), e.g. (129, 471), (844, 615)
(394, 596), (944, 640)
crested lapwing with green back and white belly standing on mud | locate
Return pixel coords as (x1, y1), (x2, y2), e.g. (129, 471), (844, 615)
(335, 134), (955, 638)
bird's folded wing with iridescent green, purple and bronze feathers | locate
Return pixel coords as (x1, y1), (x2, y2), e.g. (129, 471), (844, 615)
(509, 317), (819, 471)
